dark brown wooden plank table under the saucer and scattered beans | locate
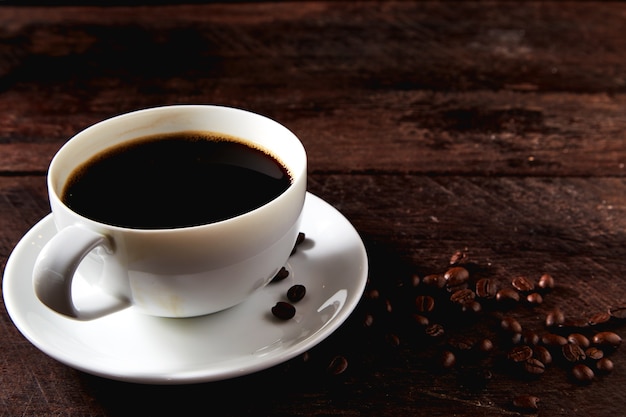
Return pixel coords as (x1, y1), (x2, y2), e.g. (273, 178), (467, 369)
(0, 1), (626, 416)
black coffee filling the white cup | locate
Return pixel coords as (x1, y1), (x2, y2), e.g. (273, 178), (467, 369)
(62, 132), (291, 229)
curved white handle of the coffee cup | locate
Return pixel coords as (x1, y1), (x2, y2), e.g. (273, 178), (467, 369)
(33, 226), (130, 320)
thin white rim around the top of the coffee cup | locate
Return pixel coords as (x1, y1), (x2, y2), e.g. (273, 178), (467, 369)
(46, 104), (307, 234)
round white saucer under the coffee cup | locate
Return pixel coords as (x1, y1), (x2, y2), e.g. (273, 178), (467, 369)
(3, 193), (368, 384)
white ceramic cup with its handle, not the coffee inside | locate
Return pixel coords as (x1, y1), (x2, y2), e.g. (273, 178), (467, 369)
(33, 105), (307, 319)
